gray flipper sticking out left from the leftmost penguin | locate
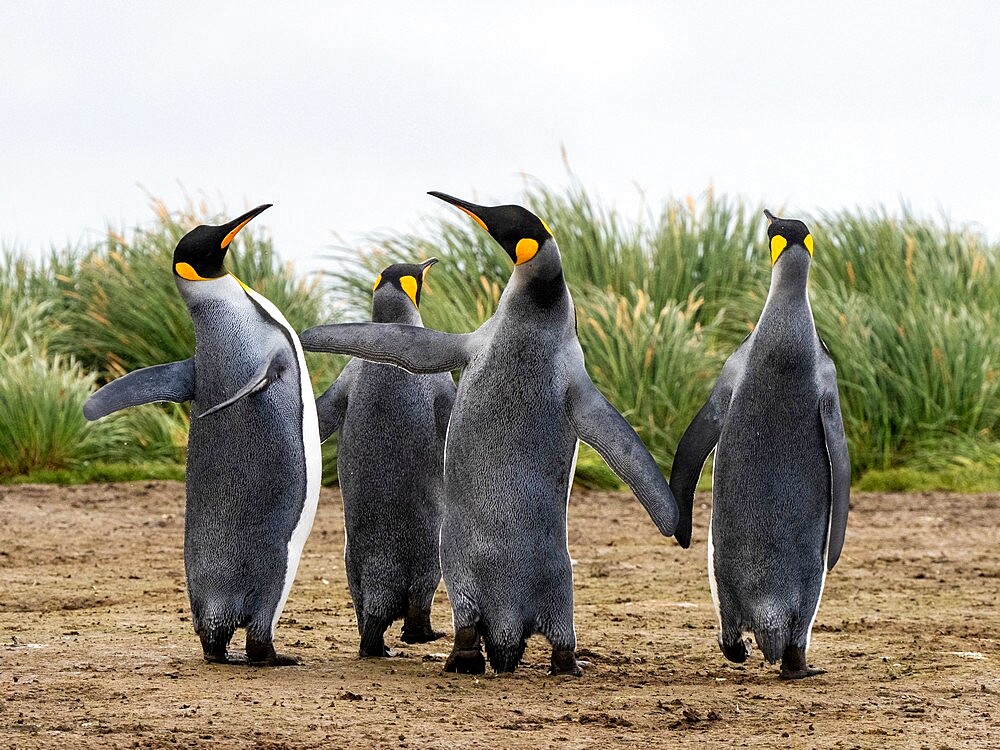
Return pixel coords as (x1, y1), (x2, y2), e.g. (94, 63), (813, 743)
(83, 359), (194, 422)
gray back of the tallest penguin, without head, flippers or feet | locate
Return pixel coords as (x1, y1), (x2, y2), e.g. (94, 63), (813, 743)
(441, 286), (582, 622)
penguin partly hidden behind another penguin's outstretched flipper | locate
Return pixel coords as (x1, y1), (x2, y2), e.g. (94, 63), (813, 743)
(316, 258), (455, 656)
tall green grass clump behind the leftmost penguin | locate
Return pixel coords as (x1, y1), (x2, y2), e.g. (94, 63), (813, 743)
(0, 204), (336, 481)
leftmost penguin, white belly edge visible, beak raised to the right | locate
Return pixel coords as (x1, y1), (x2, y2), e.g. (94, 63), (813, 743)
(83, 205), (322, 665)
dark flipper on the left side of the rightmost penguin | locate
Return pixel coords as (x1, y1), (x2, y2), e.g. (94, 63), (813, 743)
(670, 337), (749, 549)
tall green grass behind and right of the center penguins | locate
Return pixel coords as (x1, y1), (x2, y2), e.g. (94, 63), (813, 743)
(318, 186), (1000, 484)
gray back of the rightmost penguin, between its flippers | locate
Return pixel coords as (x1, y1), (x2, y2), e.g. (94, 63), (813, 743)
(711, 290), (830, 636)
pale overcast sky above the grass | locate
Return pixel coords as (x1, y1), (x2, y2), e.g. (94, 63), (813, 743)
(0, 0), (1000, 268)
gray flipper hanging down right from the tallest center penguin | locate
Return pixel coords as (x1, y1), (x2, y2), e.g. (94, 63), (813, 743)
(567, 373), (678, 536)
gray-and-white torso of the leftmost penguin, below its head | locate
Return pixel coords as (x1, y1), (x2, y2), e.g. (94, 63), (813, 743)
(185, 276), (321, 633)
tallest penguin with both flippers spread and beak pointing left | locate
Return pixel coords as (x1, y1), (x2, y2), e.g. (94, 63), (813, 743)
(301, 193), (677, 675)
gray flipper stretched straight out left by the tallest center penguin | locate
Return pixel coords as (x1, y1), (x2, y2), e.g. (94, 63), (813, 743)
(299, 323), (475, 375)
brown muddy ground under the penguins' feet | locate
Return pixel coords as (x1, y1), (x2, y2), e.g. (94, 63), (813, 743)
(0, 482), (1000, 750)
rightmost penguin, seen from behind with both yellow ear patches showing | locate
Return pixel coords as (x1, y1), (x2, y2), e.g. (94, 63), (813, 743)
(670, 211), (851, 679)
